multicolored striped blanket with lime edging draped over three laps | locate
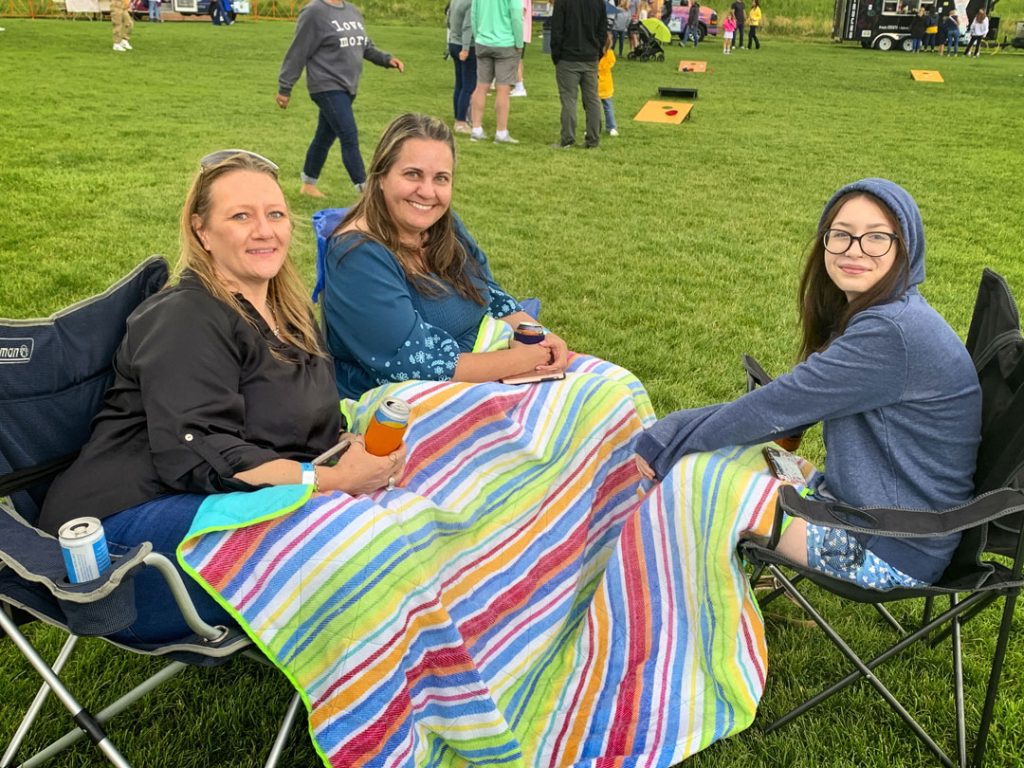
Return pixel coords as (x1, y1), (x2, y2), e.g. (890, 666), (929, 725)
(179, 355), (776, 767)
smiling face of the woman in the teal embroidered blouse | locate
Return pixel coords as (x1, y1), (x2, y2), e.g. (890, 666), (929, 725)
(381, 138), (455, 247)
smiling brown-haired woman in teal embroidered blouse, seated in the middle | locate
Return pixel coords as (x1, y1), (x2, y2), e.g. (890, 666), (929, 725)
(324, 114), (568, 397)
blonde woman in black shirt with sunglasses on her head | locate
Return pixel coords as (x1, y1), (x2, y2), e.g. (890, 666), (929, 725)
(40, 150), (406, 642)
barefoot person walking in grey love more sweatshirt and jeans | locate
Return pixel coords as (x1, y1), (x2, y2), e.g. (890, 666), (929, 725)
(276, 0), (406, 198)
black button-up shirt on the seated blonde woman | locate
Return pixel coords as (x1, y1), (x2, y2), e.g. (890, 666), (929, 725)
(39, 273), (343, 532)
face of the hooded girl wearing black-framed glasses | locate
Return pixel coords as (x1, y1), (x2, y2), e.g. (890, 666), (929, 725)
(824, 197), (898, 301)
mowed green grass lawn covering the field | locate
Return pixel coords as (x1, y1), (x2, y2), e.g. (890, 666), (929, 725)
(0, 19), (1024, 768)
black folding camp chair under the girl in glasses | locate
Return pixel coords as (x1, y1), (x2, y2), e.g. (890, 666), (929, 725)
(740, 269), (1024, 768)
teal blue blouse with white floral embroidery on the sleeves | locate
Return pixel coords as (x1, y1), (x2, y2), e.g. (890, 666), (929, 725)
(323, 214), (522, 397)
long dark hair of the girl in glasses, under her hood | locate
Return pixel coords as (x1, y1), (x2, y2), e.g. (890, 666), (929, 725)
(798, 190), (909, 360)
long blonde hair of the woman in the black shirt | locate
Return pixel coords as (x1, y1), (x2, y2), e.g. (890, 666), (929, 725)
(174, 151), (325, 360)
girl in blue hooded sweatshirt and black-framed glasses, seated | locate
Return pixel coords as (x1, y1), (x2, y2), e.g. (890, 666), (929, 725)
(637, 179), (981, 589)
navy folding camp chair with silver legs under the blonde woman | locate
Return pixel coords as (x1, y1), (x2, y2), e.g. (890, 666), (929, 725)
(0, 257), (300, 768)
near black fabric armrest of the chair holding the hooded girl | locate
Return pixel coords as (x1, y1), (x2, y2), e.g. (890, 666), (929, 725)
(778, 485), (1024, 539)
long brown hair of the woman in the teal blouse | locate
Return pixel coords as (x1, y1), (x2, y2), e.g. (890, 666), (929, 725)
(334, 113), (486, 305)
